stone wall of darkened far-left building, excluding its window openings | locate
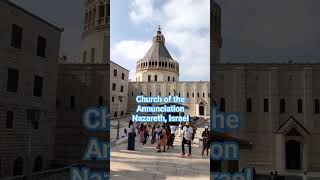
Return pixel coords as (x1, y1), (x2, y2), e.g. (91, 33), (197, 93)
(0, 1), (61, 176)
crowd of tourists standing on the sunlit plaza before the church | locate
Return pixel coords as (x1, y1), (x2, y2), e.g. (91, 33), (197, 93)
(124, 120), (210, 157)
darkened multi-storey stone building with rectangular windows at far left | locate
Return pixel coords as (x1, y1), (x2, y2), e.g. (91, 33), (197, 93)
(0, 0), (63, 177)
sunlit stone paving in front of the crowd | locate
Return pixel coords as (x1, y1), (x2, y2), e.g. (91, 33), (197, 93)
(111, 126), (210, 180)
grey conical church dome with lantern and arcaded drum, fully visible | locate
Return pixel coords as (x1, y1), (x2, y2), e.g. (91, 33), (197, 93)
(136, 27), (179, 81)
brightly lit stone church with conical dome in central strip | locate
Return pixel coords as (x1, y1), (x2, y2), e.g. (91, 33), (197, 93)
(128, 28), (210, 117)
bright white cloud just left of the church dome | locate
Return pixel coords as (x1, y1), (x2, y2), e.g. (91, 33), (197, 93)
(111, 40), (151, 79)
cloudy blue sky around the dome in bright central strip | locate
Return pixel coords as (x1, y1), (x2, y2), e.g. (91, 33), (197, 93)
(110, 0), (210, 81)
